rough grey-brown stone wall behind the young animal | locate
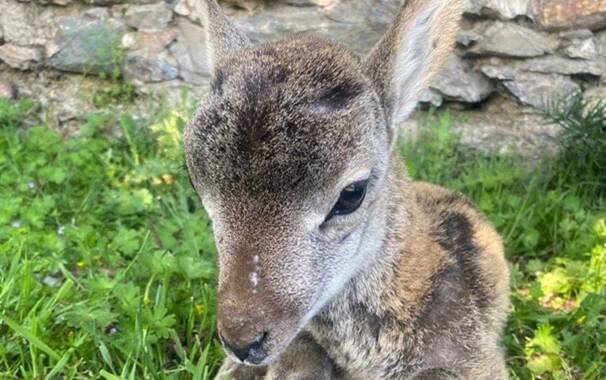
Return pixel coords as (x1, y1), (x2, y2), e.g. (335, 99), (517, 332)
(0, 0), (606, 135)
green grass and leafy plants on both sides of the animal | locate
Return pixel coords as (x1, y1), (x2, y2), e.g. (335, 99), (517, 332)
(0, 96), (606, 380)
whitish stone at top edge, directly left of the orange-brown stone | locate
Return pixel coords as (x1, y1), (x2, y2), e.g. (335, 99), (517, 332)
(465, 0), (536, 20)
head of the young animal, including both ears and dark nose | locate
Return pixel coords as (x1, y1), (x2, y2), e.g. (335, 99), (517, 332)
(185, 0), (460, 365)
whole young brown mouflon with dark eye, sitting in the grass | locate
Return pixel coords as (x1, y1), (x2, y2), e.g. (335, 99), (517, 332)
(185, 0), (509, 380)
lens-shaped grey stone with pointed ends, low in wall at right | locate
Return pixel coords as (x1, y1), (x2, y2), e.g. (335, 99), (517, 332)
(502, 73), (580, 108)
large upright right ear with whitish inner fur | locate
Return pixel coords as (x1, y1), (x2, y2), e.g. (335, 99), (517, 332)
(364, 0), (462, 128)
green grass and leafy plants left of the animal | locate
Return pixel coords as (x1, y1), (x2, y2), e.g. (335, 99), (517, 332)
(0, 105), (222, 379)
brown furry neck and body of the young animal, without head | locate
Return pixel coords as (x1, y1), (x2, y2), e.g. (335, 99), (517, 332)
(309, 159), (508, 379)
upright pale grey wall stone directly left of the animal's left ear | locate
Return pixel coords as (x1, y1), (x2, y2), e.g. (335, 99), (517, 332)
(170, 19), (210, 85)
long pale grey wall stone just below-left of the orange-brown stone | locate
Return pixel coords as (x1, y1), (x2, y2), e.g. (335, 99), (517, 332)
(469, 21), (558, 58)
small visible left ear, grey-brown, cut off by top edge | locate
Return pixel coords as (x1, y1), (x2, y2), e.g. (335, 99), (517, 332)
(196, 0), (250, 76)
